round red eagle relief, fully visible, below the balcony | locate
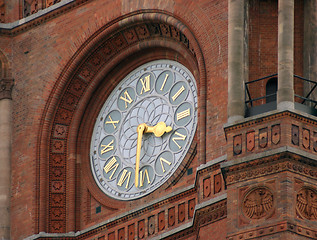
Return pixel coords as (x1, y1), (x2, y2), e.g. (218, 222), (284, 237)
(242, 187), (274, 219)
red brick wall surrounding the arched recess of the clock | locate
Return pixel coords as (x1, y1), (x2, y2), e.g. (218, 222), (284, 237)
(0, 0), (228, 239)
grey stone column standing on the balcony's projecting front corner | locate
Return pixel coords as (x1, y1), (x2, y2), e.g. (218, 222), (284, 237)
(277, 0), (294, 110)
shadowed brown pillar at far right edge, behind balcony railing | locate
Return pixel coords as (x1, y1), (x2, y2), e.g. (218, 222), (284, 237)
(304, 0), (317, 102)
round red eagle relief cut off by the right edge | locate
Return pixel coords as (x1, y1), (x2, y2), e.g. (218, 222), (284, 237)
(296, 187), (317, 220)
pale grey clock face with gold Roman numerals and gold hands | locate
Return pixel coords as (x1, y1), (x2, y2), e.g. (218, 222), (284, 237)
(90, 60), (197, 200)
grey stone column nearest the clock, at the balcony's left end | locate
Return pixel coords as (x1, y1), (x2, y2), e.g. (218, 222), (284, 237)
(228, 0), (245, 122)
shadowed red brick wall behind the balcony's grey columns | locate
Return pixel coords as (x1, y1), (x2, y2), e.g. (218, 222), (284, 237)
(249, 0), (304, 105)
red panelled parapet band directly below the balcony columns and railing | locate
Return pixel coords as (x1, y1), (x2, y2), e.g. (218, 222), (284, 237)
(225, 112), (317, 159)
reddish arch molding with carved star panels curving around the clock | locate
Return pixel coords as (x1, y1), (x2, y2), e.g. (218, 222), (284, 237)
(36, 12), (206, 233)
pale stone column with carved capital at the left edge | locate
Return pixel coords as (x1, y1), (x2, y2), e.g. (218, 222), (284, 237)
(0, 79), (13, 240)
